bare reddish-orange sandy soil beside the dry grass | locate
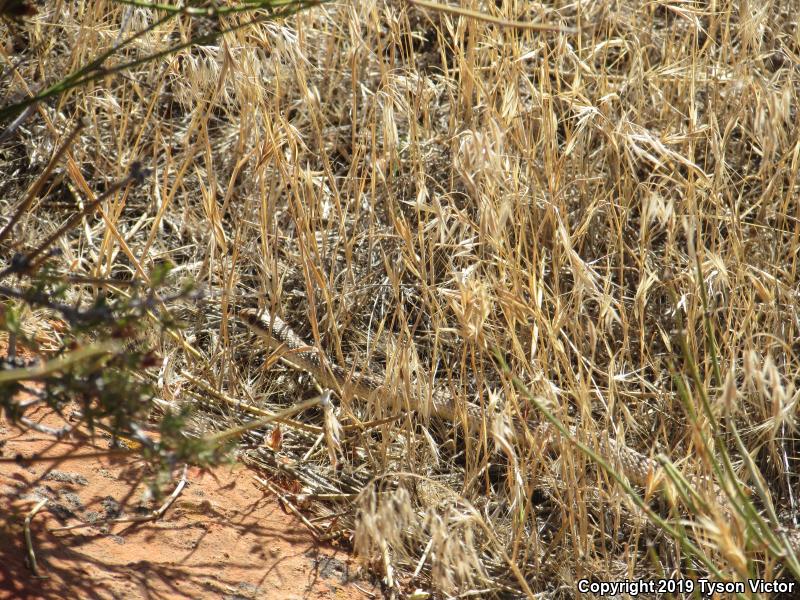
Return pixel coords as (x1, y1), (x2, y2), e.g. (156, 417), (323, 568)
(0, 409), (378, 600)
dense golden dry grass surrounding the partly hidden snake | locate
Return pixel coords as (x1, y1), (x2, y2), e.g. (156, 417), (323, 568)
(0, 0), (800, 598)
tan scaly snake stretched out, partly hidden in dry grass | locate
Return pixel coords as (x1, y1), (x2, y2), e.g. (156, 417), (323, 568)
(240, 309), (800, 554)
